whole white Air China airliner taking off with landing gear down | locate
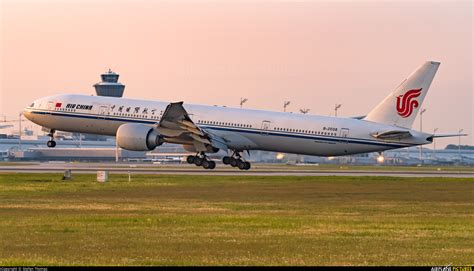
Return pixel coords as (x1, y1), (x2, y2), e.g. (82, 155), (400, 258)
(24, 61), (464, 170)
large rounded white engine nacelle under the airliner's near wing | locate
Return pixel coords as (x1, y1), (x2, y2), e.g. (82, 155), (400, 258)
(116, 123), (164, 151)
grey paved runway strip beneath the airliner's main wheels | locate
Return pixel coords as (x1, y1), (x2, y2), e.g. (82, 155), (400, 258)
(0, 163), (474, 178)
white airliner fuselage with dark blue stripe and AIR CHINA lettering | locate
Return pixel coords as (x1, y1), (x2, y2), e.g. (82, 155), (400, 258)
(24, 95), (430, 156)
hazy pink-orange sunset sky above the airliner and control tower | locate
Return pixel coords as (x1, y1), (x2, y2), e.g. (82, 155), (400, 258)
(0, 0), (474, 147)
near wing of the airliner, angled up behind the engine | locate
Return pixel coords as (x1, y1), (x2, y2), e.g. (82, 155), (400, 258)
(158, 102), (228, 151)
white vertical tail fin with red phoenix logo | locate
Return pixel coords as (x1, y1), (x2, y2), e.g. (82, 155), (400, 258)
(365, 61), (440, 128)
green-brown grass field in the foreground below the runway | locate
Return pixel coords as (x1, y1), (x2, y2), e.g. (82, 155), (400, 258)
(0, 174), (474, 265)
